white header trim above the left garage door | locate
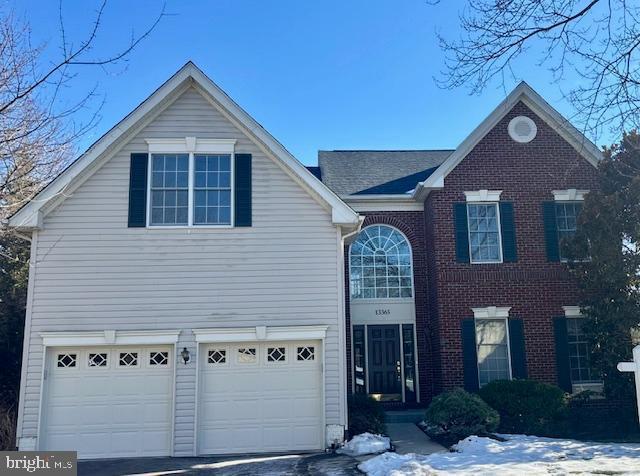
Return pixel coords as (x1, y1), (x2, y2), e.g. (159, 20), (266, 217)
(40, 330), (180, 347)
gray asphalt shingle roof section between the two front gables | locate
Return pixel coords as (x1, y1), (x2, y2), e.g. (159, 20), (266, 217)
(318, 150), (453, 196)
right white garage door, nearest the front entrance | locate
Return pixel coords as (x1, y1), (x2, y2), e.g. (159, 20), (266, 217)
(198, 341), (324, 454)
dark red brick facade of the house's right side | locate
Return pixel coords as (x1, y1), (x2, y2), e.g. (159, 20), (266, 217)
(347, 103), (596, 404)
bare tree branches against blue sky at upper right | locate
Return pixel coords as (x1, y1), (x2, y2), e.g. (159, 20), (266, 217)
(436, 0), (640, 137)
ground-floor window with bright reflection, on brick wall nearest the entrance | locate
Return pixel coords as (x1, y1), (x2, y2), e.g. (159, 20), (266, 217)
(475, 318), (511, 386)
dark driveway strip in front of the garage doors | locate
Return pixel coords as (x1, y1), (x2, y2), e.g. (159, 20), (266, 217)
(78, 454), (362, 476)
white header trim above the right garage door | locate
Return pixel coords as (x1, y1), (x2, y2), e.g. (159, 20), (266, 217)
(193, 326), (329, 343)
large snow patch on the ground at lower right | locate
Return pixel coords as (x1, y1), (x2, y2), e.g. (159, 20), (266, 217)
(358, 435), (640, 476)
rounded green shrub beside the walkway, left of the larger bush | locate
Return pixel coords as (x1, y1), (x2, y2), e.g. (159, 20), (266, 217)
(425, 388), (500, 446)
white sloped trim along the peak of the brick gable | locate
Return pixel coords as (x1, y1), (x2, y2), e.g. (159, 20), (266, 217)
(413, 81), (603, 200)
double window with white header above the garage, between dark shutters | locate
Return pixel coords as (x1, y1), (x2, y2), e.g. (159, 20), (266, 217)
(147, 138), (235, 226)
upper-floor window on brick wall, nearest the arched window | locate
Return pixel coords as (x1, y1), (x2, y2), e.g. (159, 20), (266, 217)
(467, 203), (502, 263)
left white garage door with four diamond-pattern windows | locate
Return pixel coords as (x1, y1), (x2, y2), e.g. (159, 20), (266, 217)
(40, 346), (173, 458)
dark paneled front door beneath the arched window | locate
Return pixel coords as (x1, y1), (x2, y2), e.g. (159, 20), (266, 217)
(367, 326), (402, 401)
